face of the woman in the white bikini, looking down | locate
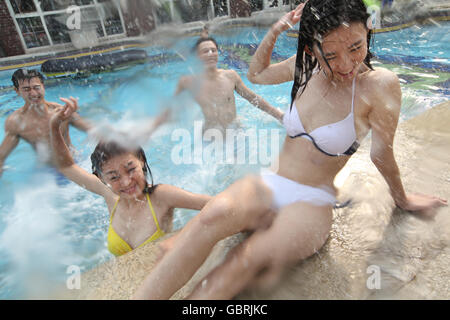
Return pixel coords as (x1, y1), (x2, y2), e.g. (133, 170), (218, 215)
(313, 22), (368, 82)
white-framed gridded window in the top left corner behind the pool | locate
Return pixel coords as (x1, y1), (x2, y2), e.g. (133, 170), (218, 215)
(6, 0), (125, 49)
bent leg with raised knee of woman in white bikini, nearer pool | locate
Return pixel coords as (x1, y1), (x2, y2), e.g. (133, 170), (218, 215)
(134, 177), (273, 299)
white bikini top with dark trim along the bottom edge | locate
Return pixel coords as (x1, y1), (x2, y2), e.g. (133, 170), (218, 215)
(283, 77), (359, 156)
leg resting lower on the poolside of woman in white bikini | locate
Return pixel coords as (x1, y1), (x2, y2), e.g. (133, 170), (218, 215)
(188, 202), (332, 299)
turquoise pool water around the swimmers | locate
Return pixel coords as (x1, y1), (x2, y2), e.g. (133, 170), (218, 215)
(0, 23), (450, 298)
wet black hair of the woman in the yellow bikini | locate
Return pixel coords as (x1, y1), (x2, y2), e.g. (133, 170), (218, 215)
(91, 142), (158, 194)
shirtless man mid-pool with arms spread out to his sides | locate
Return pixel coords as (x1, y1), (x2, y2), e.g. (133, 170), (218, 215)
(175, 37), (283, 130)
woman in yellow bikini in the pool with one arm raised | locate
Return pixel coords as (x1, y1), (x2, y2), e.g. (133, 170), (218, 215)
(50, 98), (211, 256)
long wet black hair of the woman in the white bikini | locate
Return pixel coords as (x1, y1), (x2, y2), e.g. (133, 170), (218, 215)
(291, 0), (373, 109)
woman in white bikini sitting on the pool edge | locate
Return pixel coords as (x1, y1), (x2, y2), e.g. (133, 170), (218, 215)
(135, 0), (446, 299)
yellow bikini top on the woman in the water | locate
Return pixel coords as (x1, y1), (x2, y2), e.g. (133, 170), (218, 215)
(108, 193), (165, 256)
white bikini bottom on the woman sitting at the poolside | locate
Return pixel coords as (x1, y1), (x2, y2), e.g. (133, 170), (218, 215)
(261, 170), (336, 210)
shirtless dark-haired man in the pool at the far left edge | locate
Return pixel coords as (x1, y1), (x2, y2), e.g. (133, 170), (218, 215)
(0, 69), (91, 176)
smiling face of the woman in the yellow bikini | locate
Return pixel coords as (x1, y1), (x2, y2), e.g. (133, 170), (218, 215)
(102, 152), (147, 199)
